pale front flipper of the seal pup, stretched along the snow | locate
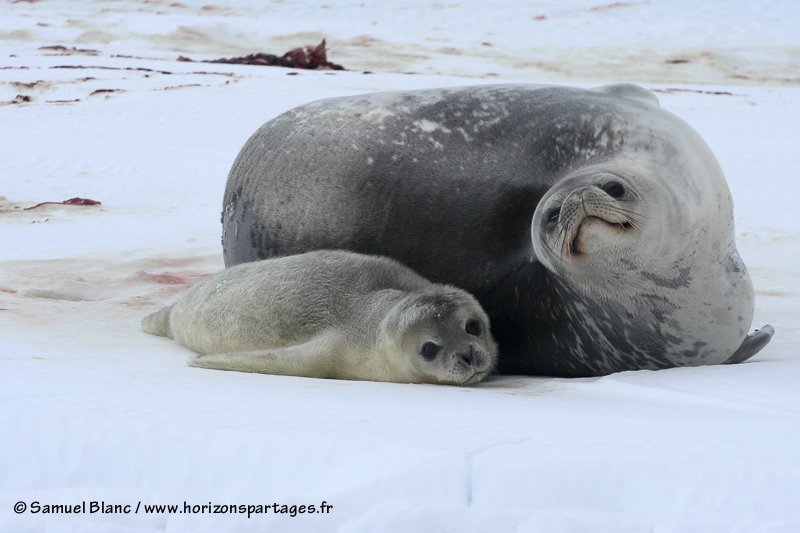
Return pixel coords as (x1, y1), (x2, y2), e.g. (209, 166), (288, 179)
(189, 334), (339, 378)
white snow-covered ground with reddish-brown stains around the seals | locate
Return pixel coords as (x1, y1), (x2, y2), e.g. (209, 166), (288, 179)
(0, 0), (800, 533)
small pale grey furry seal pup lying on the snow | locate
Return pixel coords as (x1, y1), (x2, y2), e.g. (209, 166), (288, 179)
(142, 251), (497, 385)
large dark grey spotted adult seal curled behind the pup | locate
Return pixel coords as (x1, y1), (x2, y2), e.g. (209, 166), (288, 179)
(222, 84), (773, 376)
